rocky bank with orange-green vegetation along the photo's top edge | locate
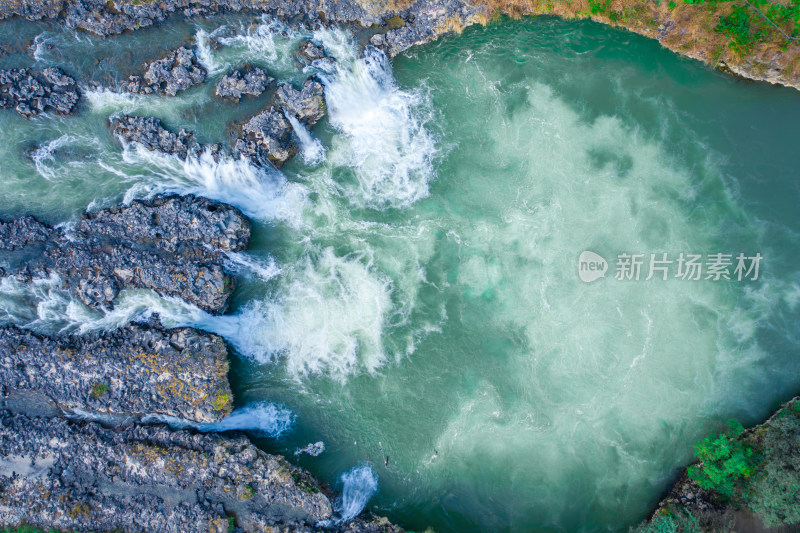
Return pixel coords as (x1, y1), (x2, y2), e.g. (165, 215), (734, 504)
(0, 0), (800, 90)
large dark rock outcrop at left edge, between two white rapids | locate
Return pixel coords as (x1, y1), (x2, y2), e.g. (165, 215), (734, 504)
(0, 196), (250, 313)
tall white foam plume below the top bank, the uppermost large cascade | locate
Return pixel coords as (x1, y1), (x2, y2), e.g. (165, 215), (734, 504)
(315, 30), (437, 209)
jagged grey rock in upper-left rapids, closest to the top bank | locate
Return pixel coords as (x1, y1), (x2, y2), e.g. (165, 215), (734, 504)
(121, 46), (206, 96)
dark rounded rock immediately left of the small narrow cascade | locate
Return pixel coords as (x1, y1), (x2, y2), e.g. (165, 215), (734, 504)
(236, 106), (297, 167)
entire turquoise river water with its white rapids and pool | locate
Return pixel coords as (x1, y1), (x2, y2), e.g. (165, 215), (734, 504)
(0, 12), (800, 532)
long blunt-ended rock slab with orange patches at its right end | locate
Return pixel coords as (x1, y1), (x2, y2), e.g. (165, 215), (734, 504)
(0, 326), (232, 422)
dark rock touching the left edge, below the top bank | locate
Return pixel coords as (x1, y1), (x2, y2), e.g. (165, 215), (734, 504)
(0, 67), (79, 118)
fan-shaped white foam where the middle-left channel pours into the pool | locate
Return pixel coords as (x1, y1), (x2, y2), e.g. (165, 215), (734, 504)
(219, 248), (391, 380)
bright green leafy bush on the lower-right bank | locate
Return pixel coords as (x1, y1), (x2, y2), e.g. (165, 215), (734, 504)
(689, 420), (758, 501)
